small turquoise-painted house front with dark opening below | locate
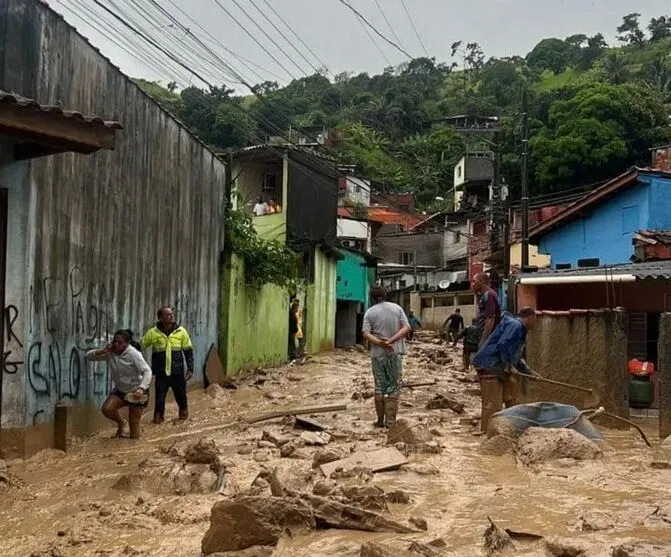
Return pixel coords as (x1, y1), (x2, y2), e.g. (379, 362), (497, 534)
(335, 247), (377, 348)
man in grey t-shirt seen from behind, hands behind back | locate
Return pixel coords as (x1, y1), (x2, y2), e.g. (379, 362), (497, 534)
(363, 286), (412, 427)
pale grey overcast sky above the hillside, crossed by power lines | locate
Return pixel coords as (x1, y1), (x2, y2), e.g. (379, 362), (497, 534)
(49, 0), (671, 89)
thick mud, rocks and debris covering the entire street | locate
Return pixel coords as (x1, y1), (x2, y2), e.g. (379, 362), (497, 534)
(0, 333), (671, 557)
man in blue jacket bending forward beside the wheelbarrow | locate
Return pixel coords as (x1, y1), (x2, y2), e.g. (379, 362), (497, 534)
(473, 307), (537, 432)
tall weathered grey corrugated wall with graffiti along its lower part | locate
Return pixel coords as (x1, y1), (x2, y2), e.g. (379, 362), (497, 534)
(0, 0), (225, 425)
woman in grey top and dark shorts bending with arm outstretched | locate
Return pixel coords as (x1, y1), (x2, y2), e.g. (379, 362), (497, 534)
(86, 329), (151, 439)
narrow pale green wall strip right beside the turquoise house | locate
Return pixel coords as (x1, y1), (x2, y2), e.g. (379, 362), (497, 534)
(306, 248), (337, 354)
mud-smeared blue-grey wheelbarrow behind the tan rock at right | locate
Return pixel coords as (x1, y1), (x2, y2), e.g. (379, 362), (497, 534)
(492, 402), (603, 441)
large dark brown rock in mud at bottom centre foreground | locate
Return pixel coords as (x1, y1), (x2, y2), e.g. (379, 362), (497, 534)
(201, 497), (315, 555)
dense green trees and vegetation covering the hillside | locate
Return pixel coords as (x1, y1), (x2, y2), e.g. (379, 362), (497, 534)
(138, 14), (671, 211)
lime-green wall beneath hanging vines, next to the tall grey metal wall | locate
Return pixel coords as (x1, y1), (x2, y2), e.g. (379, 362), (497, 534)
(219, 254), (289, 375)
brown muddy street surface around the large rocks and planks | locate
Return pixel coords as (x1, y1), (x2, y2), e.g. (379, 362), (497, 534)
(0, 335), (671, 557)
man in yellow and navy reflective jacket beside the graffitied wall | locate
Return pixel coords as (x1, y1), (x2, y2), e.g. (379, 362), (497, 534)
(142, 307), (193, 424)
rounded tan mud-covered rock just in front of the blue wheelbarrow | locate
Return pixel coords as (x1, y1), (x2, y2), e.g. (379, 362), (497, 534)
(515, 427), (603, 466)
